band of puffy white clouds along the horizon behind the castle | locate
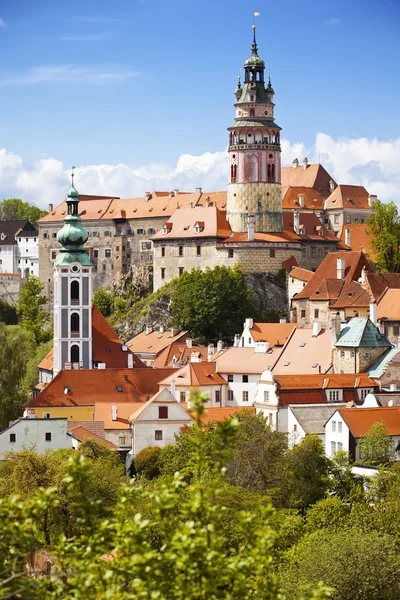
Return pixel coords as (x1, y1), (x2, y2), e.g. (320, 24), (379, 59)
(0, 133), (400, 207)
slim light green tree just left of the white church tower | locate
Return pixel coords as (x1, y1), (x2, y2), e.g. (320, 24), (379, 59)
(17, 275), (49, 344)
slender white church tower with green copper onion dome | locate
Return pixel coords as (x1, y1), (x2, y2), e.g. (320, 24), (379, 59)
(53, 172), (93, 375)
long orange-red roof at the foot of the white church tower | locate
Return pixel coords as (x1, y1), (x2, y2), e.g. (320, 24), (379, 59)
(29, 368), (176, 407)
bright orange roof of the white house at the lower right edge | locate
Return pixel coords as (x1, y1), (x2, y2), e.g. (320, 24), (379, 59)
(339, 406), (400, 438)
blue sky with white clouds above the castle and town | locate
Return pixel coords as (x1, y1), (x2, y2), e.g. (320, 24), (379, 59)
(0, 0), (400, 207)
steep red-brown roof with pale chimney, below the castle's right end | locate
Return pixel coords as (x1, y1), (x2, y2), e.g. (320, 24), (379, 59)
(295, 252), (370, 300)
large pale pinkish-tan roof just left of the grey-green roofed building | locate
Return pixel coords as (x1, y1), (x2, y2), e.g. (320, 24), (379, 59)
(272, 329), (332, 376)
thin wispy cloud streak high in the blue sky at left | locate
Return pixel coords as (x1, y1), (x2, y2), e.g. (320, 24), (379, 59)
(0, 64), (140, 87)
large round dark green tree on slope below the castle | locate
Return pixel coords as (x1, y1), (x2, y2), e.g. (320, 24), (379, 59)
(171, 267), (255, 340)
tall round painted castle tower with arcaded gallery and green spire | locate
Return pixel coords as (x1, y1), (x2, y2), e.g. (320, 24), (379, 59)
(227, 25), (283, 233)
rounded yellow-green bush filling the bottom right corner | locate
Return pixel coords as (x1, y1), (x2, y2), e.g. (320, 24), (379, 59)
(282, 528), (400, 600)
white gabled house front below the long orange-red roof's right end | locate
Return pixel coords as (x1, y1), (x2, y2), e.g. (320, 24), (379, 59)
(129, 389), (193, 456)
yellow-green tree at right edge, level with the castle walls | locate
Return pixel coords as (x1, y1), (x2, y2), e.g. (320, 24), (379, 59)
(367, 200), (400, 273)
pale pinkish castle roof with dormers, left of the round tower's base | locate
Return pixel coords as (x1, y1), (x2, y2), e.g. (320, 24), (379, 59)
(152, 206), (231, 240)
